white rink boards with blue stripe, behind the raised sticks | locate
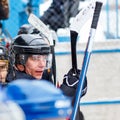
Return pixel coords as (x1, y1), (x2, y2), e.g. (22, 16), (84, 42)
(56, 40), (120, 120)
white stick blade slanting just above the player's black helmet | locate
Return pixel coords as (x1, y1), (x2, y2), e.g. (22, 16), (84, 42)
(28, 13), (53, 45)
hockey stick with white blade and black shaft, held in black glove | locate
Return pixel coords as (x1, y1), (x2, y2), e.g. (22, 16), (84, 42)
(70, 1), (95, 74)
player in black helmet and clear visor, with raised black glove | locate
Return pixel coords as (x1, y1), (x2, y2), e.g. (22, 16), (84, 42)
(7, 34), (87, 120)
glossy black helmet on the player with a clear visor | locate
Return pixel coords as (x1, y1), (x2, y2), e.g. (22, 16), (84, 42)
(12, 34), (51, 65)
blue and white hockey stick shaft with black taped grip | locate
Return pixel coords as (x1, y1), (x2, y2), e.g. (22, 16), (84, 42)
(71, 2), (102, 120)
